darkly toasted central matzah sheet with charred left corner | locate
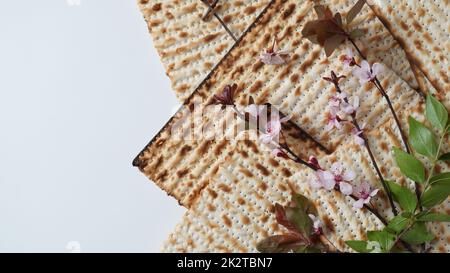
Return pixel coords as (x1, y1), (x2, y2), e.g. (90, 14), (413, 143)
(134, 1), (428, 206)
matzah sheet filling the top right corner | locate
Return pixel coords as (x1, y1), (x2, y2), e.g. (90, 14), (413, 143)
(371, 0), (450, 109)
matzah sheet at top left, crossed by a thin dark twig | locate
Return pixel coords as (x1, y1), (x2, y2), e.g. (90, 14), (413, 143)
(138, 0), (270, 101)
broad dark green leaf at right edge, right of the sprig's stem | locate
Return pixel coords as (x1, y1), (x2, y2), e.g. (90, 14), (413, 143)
(421, 173), (450, 208)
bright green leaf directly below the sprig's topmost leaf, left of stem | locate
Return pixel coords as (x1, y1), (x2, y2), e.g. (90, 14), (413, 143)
(409, 117), (438, 158)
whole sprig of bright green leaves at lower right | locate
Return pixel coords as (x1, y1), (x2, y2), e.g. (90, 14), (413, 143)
(346, 95), (450, 253)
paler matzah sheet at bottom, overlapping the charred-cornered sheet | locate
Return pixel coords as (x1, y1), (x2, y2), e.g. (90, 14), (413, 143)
(162, 135), (450, 252)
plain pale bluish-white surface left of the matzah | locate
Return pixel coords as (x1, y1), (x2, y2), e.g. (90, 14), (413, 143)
(0, 0), (184, 252)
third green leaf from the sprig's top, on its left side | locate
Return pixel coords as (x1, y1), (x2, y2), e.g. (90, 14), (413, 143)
(394, 148), (425, 183)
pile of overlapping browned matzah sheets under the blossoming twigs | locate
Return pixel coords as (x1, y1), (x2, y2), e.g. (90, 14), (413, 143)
(133, 0), (450, 252)
